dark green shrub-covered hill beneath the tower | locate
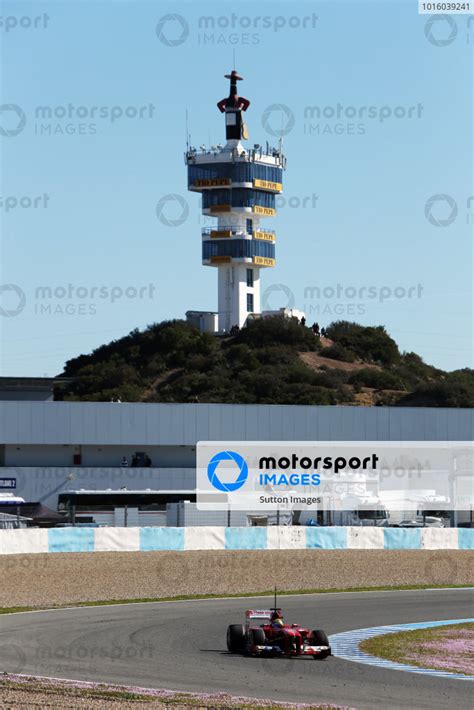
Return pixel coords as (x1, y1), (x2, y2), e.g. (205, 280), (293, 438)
(58, 317), (474, 407)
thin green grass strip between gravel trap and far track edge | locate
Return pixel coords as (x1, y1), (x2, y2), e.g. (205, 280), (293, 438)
(0, 584), (472, 614)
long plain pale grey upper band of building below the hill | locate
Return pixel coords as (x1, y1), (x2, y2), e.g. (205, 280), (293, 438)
(0, 401), (474, 446)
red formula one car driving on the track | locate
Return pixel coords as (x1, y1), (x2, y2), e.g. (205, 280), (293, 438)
(227, 607), (331, 660)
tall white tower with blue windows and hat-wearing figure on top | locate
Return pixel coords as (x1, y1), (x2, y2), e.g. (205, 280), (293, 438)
(185, 70), (286, 333)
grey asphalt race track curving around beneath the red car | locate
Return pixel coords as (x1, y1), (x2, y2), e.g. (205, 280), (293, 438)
(0, 589), (474, 710)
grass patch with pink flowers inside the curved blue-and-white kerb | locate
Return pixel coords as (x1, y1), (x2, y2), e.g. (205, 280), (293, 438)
(359, 623), (474, 676)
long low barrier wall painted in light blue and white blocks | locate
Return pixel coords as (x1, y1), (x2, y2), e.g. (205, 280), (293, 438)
(0, 526), (474, 555)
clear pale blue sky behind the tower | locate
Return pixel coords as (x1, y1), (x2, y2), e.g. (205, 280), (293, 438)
(0, 0), (474, 376)
